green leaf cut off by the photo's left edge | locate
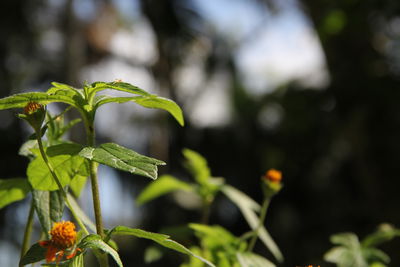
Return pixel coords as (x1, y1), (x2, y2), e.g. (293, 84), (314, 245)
(0, 178), (31, 209)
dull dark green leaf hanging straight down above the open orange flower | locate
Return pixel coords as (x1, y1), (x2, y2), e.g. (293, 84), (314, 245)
(32, 190), (64, 239)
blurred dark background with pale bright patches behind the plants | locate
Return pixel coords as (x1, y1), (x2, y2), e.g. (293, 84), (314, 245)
(0, 0), (400, 266)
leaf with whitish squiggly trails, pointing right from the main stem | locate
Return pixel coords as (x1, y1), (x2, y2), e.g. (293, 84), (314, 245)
(79, 143), (165, 180)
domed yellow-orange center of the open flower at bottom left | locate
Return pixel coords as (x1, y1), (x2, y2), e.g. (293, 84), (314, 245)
(50, 221), (76, 248)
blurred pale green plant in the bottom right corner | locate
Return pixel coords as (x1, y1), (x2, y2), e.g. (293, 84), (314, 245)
(324, 224), (400, 267)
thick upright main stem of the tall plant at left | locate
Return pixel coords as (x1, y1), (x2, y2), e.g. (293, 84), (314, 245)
(84, 120), (108, 267)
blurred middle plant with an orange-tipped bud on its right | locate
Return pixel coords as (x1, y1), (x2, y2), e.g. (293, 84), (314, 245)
(137, 149), (283, 267)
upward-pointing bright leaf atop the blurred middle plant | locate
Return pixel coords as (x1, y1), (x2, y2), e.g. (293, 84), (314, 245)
(182, 148), (211, 184)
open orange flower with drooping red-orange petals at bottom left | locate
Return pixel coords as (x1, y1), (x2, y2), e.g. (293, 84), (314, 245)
(39, 221), (80, 262)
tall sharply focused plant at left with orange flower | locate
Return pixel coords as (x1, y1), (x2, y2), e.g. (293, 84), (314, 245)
(0, 81), (214, 267)
